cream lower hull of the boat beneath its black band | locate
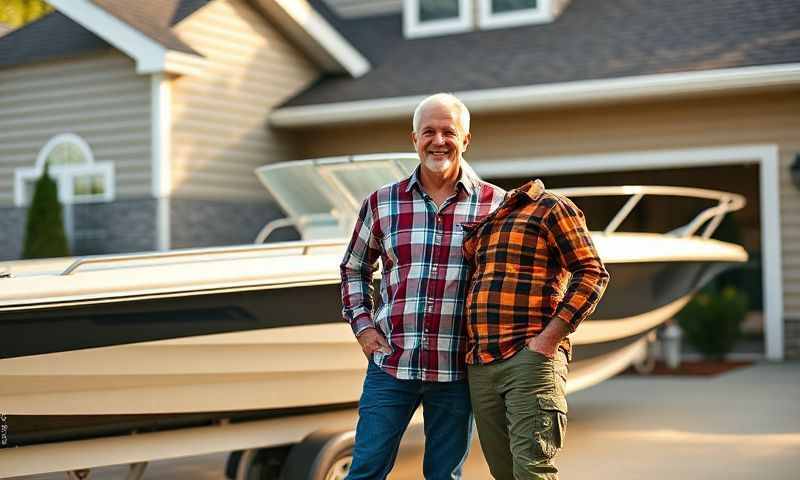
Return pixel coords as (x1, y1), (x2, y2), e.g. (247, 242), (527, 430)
(0, 298), (688, 415)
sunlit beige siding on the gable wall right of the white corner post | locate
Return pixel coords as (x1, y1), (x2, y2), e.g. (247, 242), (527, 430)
(171, 0), (319, 200)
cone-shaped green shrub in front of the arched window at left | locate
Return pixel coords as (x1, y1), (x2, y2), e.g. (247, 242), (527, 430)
(22, 164), (69, 258)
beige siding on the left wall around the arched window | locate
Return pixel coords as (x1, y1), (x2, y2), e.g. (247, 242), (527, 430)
(0, 52), (151, 206)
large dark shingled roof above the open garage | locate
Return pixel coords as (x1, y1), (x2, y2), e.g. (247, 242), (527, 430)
(284, 0), (800, 107)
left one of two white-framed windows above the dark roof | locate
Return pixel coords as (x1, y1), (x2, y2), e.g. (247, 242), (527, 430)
(403, 0), (473, 38)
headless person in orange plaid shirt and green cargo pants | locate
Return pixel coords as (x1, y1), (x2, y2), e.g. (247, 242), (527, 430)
(463, 180), (609, 480)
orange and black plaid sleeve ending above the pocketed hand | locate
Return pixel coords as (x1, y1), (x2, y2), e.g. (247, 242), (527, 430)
(545, 197), (609, 332)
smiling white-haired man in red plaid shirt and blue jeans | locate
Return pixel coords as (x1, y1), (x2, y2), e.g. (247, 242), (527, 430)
(341, 94), (505, 480)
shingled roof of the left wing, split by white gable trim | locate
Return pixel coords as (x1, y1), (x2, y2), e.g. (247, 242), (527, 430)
(0, 0), (211, 67)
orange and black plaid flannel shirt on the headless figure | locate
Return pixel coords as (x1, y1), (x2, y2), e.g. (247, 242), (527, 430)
(462, 180), (609, 364)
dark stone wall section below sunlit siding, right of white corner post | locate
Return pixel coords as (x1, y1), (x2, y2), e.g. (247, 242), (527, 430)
(170, 198), (299, 249)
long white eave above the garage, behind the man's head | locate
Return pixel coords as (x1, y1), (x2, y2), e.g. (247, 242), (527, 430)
(269, 63), (800, 128)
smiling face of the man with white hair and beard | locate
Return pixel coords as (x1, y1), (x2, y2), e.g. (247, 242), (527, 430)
(411, 103), (470, 175)
